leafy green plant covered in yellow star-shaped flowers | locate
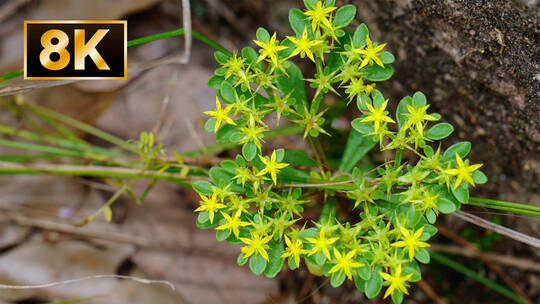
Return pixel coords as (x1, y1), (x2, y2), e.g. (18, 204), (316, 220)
(193, 0), (487, 303)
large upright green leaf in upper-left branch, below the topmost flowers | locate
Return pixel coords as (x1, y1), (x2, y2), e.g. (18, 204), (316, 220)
(277, 62), (308, 114)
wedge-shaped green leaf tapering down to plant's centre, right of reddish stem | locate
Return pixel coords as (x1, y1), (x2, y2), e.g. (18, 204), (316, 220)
(339, 126), (377, 172)
